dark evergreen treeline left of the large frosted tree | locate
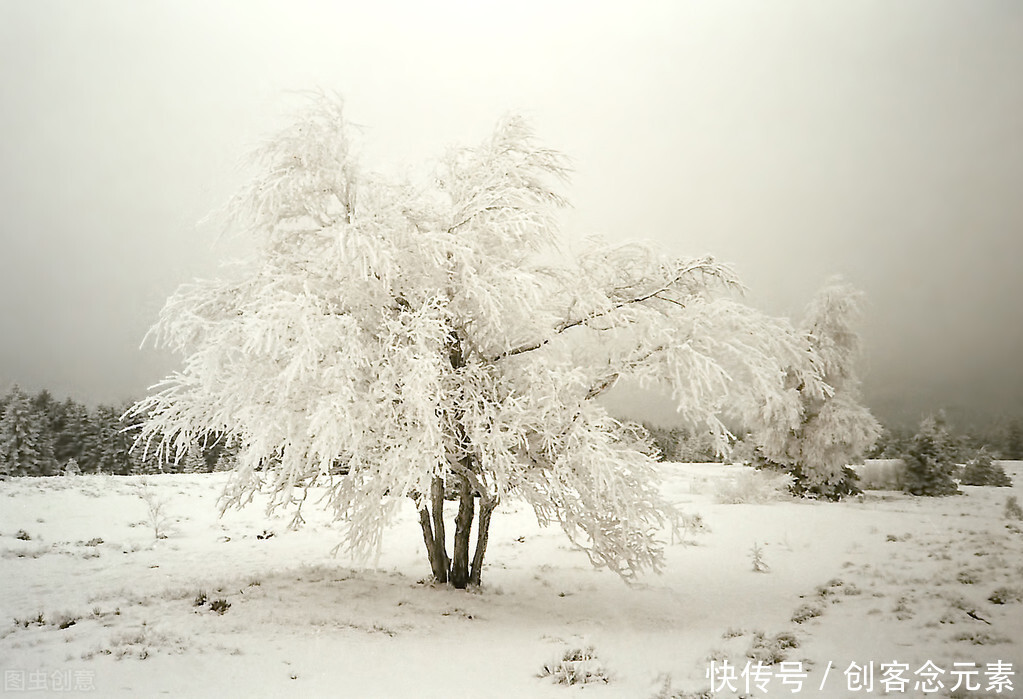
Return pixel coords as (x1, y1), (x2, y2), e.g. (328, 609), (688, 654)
(0, 386), (231, 476)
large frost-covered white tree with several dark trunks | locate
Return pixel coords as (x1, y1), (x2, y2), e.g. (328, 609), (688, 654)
(128, 97), (830, 587)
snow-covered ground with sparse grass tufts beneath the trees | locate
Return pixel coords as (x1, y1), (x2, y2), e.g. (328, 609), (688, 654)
(0, 463), (1023, 699)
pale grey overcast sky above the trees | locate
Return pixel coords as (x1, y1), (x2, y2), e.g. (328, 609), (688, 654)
(0, 0), (1023, 423)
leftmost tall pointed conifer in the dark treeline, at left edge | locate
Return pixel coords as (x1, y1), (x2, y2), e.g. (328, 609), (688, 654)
(0, 386), (56, 476)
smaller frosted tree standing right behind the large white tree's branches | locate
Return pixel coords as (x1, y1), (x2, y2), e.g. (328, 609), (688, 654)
(757, 279), (881, 499)
